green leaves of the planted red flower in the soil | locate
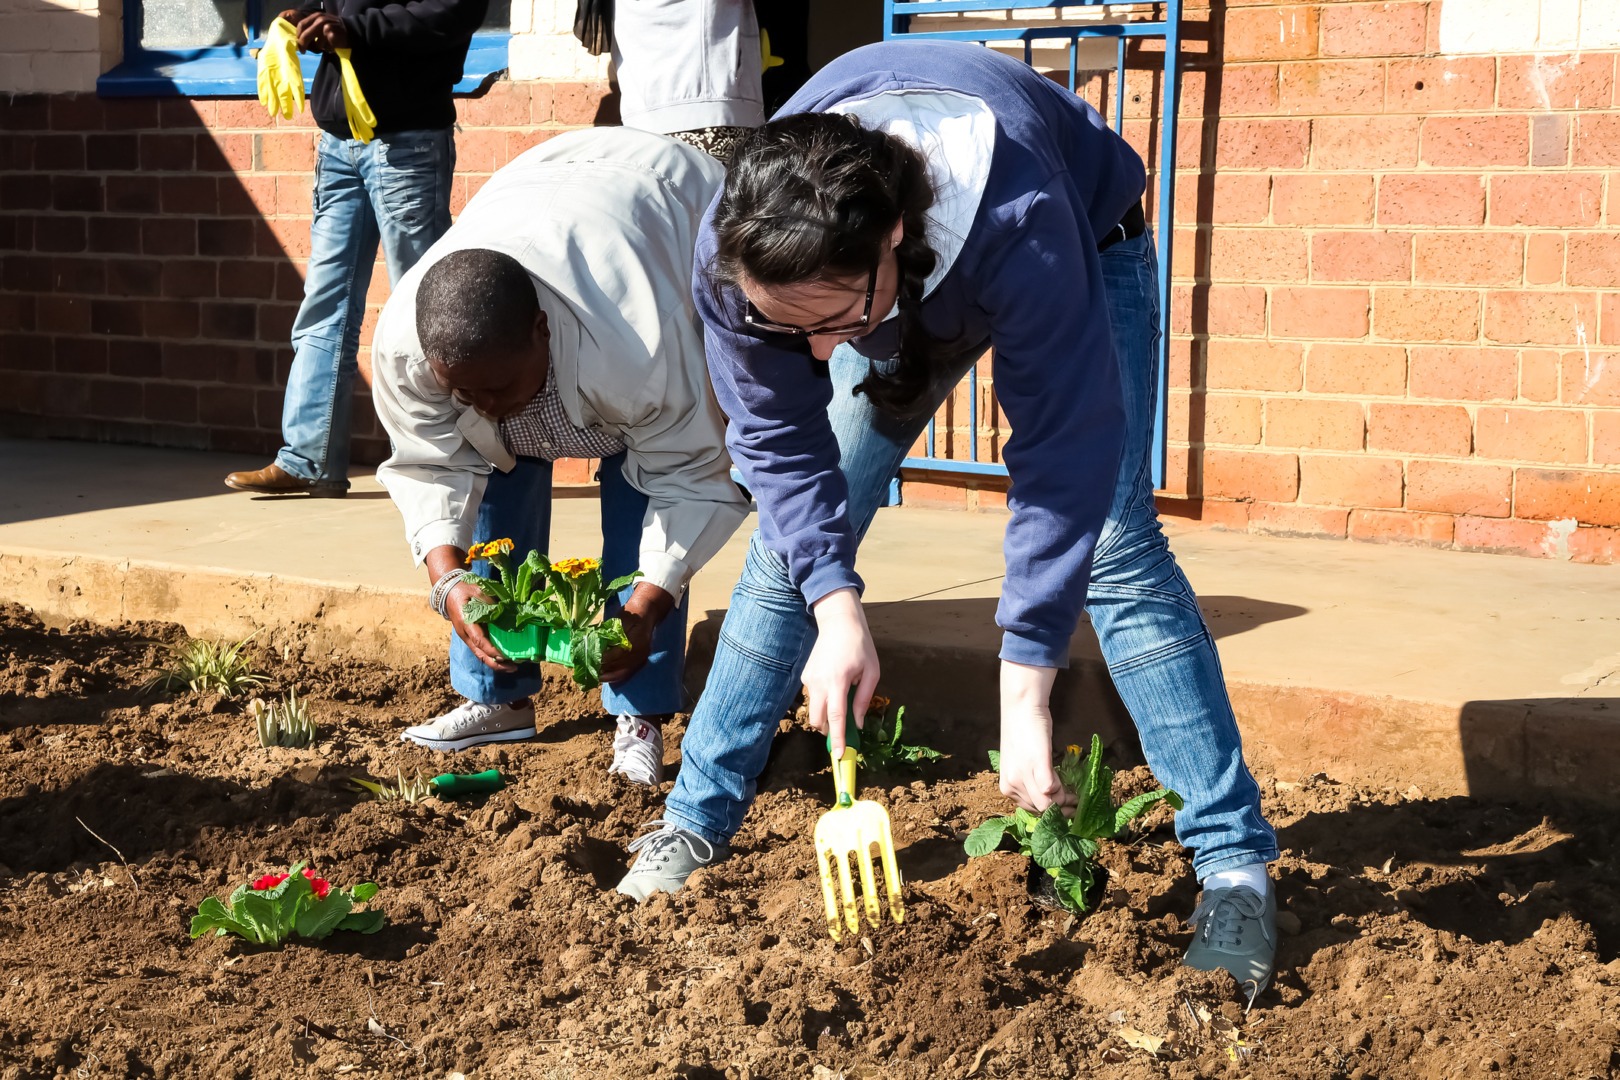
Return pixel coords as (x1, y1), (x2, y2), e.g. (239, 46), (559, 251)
(191, 863), (387, 949)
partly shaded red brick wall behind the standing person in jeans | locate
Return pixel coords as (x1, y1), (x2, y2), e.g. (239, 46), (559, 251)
(0, 83), (608, 479)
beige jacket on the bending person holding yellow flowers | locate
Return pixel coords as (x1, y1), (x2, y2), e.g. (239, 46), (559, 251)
(371, 128), (747, 596)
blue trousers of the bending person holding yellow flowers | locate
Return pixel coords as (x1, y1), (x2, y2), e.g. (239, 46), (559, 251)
(450, 453), (687, 716)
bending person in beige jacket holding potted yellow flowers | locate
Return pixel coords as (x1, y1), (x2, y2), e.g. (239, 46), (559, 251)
(373, 128), (747, 784)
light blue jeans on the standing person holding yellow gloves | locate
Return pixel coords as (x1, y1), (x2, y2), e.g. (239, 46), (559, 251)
(275, 128), (455, 487)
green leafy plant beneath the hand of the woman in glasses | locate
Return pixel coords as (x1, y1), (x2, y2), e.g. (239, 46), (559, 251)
(962, 735), (1181, 912)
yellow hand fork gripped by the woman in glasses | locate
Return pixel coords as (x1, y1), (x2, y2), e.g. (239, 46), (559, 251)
(815, 714), (906, 941)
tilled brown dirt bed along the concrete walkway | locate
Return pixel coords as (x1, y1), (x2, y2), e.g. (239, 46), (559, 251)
(0, 607), (1620, 1078)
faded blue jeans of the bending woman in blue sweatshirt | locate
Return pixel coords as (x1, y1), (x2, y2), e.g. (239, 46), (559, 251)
(664, 235), (1277, 878)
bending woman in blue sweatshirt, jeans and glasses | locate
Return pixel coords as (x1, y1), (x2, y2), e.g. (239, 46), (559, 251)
(619, 42), (1277, 988)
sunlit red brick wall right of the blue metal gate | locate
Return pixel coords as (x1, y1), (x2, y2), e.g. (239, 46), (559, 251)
(1166, 2), (1620, 562)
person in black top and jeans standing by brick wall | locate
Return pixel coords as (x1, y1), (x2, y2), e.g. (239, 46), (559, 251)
(225, 0), (488, 499)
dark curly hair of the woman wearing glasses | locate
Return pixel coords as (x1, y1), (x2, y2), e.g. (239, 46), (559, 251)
(708, 113), (940, 418)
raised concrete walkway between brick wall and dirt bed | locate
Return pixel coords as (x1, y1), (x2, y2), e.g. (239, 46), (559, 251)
(0, 440), (1620, 801)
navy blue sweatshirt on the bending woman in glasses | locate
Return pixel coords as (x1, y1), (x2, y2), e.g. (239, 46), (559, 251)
(693, 42), (1147, 667)
